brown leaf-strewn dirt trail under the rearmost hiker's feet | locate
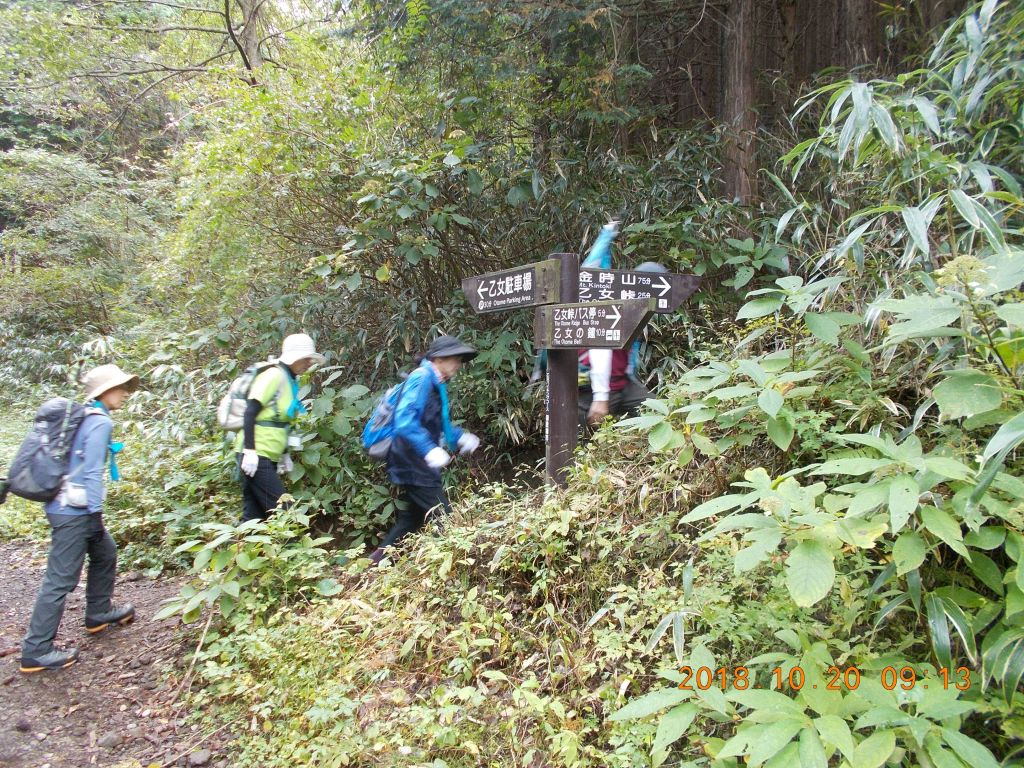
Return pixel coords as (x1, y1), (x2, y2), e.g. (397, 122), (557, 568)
(0, 543), (228, 768)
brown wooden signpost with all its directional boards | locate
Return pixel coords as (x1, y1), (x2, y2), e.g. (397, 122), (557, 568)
(462, 253), (700, 484)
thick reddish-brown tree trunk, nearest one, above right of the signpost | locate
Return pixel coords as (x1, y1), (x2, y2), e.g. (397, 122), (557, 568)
(722, 0), (757, 205)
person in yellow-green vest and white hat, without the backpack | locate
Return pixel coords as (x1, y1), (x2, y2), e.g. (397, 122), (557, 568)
(234, 334), (324, 522)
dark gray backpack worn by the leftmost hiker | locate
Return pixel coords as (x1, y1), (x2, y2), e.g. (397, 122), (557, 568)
(7, 397), (96, 502)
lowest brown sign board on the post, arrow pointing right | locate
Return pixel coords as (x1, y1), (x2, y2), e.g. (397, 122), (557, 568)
(534, 299), (655, 349)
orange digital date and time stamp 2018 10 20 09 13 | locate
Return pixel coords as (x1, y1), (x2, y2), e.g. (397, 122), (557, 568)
(677, 666), (971, 691)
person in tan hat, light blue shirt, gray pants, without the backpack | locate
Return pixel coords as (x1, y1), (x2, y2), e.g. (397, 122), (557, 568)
(22, 366), (139, 673)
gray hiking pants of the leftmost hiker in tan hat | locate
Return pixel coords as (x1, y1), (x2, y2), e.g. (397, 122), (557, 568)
(22, 514), (118, 658)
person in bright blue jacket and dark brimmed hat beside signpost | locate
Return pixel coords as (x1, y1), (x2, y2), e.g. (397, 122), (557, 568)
(370, 336), (480, 564)
